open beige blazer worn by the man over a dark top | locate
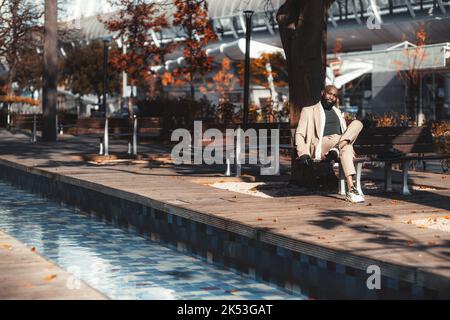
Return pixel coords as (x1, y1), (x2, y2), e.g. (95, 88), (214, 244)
(295, 101), (347, 160)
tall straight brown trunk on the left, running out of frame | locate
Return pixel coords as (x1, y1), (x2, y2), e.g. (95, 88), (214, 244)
(42, 0), (58, 142)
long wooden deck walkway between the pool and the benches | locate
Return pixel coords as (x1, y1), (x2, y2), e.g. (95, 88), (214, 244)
(0, 128), (450, 298)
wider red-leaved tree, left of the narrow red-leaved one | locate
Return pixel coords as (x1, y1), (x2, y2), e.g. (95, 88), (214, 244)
(99, 0), (173, 109)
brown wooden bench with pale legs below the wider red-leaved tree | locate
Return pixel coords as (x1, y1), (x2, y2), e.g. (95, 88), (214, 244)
(68, 118), (162, 155)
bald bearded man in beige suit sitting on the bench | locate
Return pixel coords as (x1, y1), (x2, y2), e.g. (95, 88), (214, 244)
(295, 86), (365, 203)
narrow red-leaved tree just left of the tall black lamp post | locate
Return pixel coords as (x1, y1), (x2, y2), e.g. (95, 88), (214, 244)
(173, 0), (217, 99)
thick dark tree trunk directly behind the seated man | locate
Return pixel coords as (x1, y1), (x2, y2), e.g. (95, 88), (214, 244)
(277, 0), (337, 187)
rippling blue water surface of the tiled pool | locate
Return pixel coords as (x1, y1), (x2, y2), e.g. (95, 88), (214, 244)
(0, 181), (302, 300)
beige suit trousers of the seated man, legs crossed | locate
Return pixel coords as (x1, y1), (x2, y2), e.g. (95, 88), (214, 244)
(322, 120), (363, 177)
